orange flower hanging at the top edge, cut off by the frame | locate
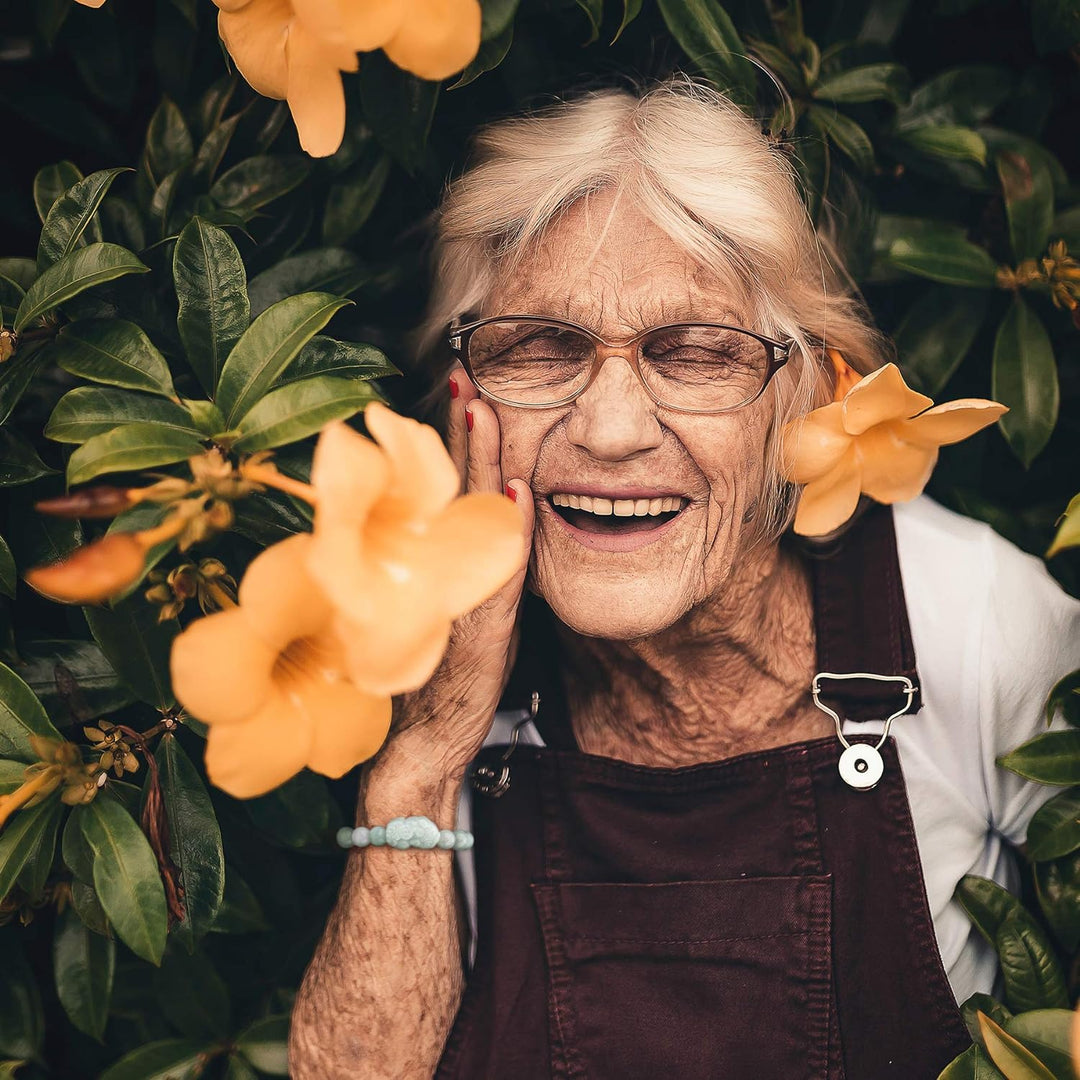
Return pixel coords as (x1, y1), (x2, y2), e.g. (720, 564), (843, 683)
(214, 0), (481, 158)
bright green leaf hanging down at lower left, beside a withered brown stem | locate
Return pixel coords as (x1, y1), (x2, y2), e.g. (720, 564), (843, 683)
(71, 795), (166, 964)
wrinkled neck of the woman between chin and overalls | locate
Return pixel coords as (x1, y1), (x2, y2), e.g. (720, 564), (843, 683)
(557, 548), (816, 766)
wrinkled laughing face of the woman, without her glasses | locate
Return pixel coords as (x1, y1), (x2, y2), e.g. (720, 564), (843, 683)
(484, 193), (774, 639)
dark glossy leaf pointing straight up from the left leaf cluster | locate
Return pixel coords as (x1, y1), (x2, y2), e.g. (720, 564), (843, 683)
(173, 217), (251, 394)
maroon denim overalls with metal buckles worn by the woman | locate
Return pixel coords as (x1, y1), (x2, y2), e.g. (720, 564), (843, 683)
(436, 508), (970, 1080)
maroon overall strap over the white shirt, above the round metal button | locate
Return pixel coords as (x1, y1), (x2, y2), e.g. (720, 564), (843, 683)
(805, 504), (922, 720)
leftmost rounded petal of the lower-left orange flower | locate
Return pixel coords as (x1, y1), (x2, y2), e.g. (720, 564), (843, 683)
(170, 608), (278, 725)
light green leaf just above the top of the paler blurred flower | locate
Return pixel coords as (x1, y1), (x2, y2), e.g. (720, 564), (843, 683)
(233, 375), (377, 454)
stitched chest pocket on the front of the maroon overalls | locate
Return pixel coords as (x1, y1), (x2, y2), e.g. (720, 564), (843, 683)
(531, 875), (843, 1080)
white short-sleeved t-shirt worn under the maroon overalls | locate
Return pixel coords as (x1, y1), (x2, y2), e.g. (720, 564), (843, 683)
(457, 496), (1080, 1002)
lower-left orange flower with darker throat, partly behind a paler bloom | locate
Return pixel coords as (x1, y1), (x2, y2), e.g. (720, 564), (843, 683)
(172, 535), (391, 798)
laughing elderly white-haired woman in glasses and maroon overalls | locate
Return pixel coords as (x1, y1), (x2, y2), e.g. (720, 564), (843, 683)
(291, 84), (1080, 1080)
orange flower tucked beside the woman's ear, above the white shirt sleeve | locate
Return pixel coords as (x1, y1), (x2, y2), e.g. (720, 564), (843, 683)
(781, 361), (1008, 536)
